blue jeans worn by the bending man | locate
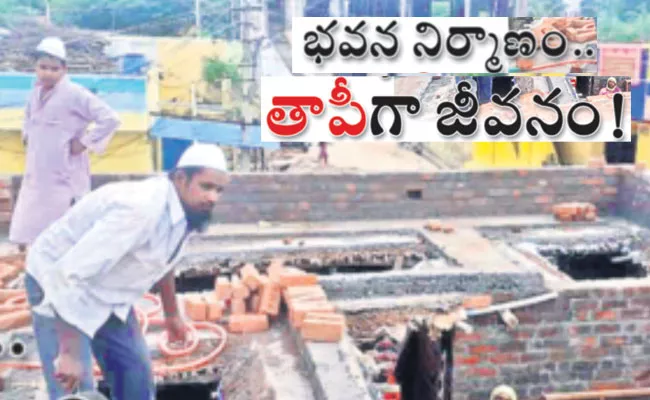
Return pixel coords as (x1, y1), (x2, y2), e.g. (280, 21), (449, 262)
(25, 274), (155, 400)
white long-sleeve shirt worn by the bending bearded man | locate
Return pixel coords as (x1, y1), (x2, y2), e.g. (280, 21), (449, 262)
(26, 176), (187, 338)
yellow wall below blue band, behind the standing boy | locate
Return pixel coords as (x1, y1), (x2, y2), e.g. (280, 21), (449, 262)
(0, 109), (156, 175)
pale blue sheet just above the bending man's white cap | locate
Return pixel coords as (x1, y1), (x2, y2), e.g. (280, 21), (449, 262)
(151, 117), (280, 149)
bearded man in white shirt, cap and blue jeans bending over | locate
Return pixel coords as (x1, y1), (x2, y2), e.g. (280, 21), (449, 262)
(25, 144), (229, 400)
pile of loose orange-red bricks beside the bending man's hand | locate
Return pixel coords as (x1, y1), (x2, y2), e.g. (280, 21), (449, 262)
(184, 260), (345, 342)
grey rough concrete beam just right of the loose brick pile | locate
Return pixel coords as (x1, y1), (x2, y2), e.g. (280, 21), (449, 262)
(319, 268), (546, 300)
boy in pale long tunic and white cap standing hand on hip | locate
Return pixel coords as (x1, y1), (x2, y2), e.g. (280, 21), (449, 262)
(9, 38), (120, 251)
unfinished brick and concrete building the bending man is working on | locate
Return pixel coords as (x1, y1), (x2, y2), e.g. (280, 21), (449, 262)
(0, 160), (650, 400)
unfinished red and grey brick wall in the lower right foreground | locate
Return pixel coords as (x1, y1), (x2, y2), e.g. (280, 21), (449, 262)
(454, 285), (650, 400)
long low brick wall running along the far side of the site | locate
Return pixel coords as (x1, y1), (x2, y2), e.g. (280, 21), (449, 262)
(0, 167), (621, 227)
